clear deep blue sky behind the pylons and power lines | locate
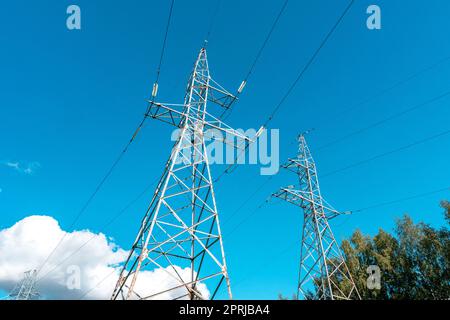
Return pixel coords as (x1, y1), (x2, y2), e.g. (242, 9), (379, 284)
(0, 0), (450, 299)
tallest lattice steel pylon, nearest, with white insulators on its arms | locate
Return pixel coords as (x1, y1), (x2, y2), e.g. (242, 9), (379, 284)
(112, 47), (252, 300)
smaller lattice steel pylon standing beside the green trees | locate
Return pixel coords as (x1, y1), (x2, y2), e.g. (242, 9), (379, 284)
(273, 134), (361, 300)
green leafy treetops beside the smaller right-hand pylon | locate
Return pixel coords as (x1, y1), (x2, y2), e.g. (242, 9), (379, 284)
(340, 201), (450, 300)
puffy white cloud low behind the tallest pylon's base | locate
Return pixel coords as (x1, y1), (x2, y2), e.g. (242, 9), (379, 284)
(0, 216), (209, 299)
